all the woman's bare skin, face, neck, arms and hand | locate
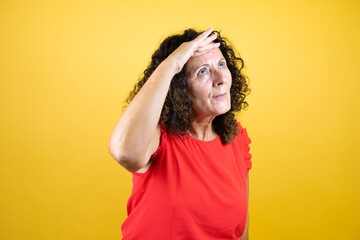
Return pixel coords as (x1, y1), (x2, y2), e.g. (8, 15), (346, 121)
(109, 28), (248, 240)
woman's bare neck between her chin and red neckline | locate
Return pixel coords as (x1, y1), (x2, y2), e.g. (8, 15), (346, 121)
(188, 117), (217, 141)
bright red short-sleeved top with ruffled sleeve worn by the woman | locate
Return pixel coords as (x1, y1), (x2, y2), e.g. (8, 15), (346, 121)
(121, 123), (251, 240)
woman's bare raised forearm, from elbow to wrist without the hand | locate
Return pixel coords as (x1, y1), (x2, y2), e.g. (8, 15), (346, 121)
(109, 60), (175, 167)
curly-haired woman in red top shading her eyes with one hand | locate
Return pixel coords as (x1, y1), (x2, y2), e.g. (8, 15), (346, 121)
(109, 28), (251, 240)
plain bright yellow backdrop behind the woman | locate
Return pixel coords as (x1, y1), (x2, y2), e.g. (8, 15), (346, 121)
(0, 0), (360, 240)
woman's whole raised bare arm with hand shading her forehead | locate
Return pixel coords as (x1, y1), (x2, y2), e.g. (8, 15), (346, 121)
(109, 28), (220, 172)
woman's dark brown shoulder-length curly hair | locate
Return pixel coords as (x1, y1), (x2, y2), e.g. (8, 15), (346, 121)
(124, 29), (251, 144)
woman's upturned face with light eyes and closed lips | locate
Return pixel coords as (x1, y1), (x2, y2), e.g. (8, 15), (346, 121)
(185, 48), (231, 118)
